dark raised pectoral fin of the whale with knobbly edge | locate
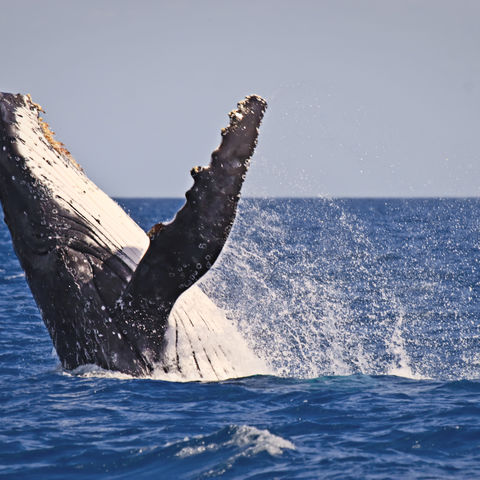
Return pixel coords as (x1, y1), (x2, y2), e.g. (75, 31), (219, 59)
(115, 96), (266, 368)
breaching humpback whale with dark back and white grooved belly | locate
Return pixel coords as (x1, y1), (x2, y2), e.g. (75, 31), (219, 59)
(0, 93), (266, 379)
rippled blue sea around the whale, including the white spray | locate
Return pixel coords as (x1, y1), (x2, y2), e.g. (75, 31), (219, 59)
(0, 199), (480, 479)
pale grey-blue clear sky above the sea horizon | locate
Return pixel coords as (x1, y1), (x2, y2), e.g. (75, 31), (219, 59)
(0, 0), (480, 197)
